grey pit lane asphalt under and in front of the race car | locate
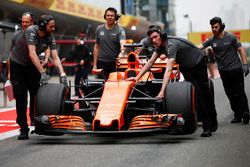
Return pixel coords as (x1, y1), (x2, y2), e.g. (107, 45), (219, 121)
(0, 75), (250, 167)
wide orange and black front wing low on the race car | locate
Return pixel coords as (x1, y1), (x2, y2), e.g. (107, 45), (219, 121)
(32, 114), (185, 135)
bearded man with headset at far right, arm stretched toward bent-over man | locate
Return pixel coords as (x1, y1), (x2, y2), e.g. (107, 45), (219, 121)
(199, 17), (249, 124)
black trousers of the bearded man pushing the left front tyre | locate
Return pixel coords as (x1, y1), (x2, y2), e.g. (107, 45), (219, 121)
(10, 61), (41, 131)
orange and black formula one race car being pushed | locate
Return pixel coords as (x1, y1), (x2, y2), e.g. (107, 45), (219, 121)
(33, 44), (197, 135)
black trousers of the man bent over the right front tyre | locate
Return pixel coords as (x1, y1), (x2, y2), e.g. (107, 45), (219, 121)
(180, 61), (217, 129)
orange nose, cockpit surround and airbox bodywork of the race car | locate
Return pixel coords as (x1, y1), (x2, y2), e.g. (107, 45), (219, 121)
(92, 52), (153, 130)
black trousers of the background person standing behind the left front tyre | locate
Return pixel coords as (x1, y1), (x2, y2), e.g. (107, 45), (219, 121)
(75, 66), (90, 96)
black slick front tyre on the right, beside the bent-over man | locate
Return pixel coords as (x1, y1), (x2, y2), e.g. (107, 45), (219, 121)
(163, 81), (197, 134)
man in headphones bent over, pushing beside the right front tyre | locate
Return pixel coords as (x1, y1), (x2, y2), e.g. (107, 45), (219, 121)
(129, 28), (218, 137)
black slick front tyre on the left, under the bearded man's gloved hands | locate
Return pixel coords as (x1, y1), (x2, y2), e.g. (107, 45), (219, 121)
(35, 83), (70, 116)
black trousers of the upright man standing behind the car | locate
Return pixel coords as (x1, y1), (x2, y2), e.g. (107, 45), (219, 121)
(97, 61), (116, 79)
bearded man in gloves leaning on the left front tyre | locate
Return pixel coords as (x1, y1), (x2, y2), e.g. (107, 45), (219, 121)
(10, 15), (67, 140)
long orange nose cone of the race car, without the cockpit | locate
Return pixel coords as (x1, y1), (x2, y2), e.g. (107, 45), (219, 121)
(92, 81), (135, 130)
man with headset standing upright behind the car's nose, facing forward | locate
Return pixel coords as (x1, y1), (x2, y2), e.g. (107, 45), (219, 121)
(93, 7), (126, 79)
